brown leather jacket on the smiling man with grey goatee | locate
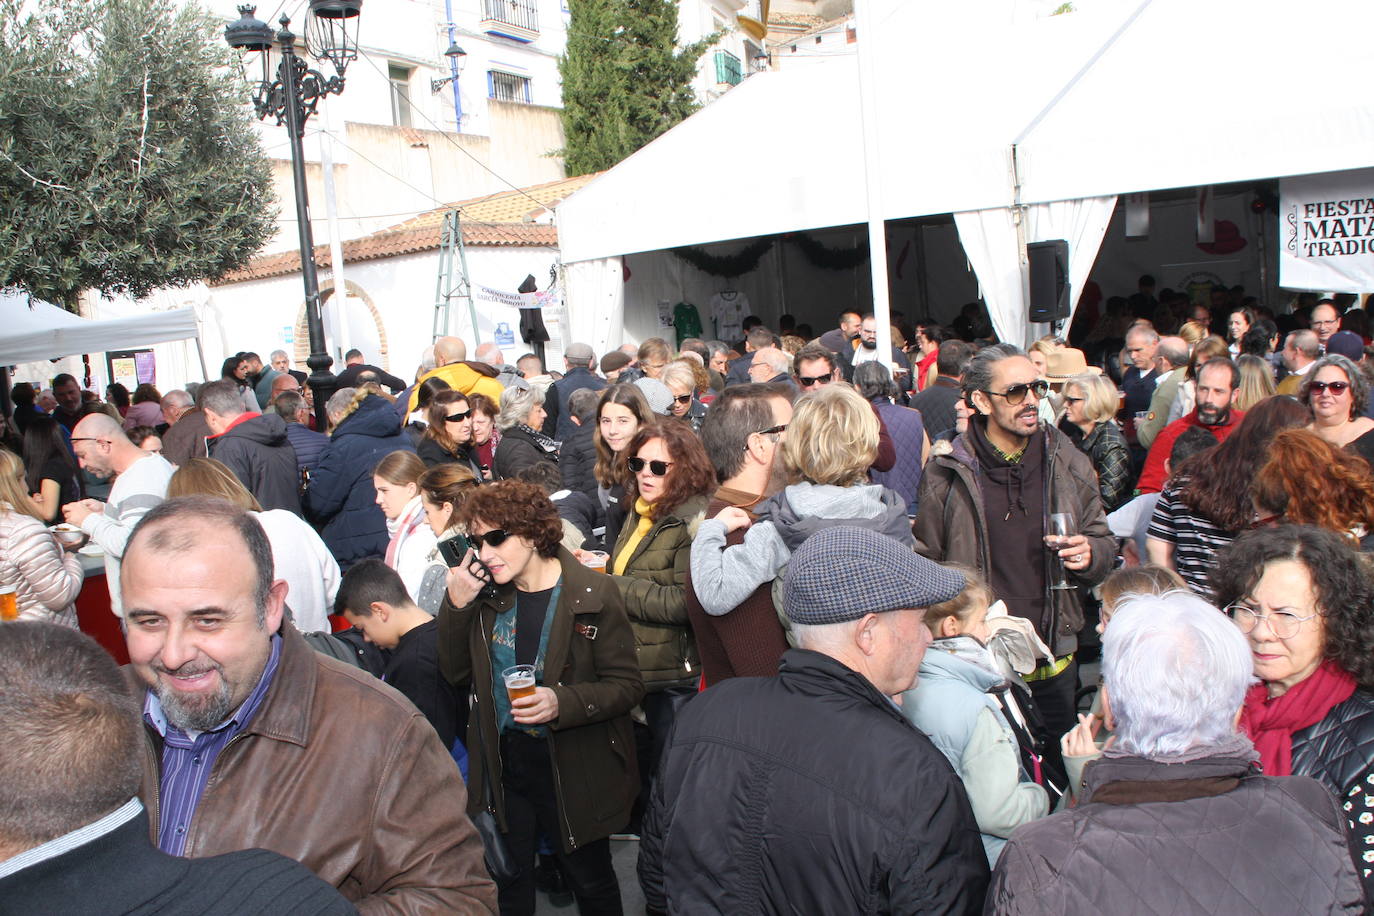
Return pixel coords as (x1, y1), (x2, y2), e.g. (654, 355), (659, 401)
(126, 625), (496, 916)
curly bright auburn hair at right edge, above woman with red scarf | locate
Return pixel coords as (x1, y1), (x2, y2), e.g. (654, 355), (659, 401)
(1250, 430), (1374, 551)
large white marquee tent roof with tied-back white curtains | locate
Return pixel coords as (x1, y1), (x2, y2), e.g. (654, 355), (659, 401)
(558, 0), (1374, 350)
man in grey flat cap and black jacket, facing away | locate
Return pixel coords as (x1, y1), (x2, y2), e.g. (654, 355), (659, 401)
(639, 527), (988, 913)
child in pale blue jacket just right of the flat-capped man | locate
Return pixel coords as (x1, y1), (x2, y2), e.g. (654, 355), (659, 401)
(901, 567), (1050, 864)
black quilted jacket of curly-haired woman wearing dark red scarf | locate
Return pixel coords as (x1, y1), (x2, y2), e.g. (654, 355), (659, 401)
(1293, 688), (1374, 900)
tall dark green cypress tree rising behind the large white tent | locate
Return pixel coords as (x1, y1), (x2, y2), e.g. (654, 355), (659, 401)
(558, 0), (720, 174)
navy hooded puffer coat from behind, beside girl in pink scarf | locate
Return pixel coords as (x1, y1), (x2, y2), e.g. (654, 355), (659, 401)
(305, 394), (414, 570)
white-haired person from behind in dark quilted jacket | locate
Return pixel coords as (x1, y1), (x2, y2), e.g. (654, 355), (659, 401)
(984, 591), (1364, 916)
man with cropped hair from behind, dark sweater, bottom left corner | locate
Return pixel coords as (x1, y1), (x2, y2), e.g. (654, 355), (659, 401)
(0, 621), (357, 916)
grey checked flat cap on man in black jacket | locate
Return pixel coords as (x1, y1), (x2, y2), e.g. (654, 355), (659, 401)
(782, 525), (965, 623)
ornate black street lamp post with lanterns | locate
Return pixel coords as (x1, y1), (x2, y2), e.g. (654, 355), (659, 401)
(224, 0), (363, 433)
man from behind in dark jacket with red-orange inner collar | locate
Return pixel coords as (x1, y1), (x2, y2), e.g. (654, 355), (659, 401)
(201, 379), (301, 515)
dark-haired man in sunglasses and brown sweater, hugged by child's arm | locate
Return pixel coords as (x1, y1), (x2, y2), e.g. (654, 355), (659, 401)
(686, 385), (794, 685)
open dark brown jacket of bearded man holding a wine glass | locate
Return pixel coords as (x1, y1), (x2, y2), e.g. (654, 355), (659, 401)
(912, 426), (1117, 656)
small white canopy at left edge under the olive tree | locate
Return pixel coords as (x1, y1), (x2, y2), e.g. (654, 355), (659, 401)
(0, 293), (201, 365)
